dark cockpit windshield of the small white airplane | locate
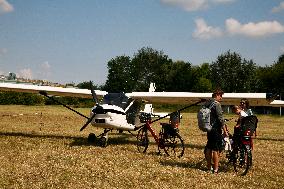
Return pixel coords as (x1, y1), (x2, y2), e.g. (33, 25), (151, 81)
(103, 93), (129, 109)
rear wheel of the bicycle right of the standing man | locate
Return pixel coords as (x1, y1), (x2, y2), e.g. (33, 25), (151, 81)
(233, 145), (252, 176)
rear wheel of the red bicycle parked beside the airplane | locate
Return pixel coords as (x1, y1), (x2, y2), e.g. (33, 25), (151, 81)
(162, 133), (184, 158)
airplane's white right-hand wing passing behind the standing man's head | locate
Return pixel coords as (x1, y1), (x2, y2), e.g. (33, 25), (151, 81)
(126, 92), (279, 107)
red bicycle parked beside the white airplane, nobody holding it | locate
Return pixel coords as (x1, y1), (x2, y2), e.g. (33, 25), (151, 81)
(136, 99), (205, 158)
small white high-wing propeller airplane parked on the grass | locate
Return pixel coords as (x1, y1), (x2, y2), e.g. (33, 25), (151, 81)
(0, 83), (284, 146)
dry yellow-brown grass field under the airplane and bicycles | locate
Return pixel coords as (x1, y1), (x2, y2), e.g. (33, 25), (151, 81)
(0, 106), (284, 189)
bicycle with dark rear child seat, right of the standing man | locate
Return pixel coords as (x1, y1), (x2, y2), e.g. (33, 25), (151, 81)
(226, 116), (258, 176)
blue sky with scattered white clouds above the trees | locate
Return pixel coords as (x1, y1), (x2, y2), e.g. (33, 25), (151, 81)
(0, 0), (284, 84)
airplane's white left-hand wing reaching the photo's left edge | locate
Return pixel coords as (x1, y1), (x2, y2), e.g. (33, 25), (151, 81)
(0, 83), (107, 98)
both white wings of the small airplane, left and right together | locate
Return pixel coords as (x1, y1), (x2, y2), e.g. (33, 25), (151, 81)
(0, 83), (284, 107)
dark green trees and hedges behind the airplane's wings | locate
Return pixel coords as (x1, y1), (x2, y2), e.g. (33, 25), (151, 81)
(0, 47), (284, 107)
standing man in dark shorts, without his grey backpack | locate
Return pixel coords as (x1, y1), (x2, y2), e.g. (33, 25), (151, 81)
(205, 89), (228, 173)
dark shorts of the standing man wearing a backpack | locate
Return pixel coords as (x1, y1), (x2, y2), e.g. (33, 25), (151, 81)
(206, 128), (225, 152)
